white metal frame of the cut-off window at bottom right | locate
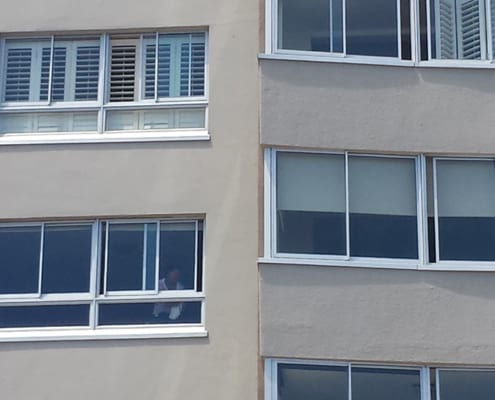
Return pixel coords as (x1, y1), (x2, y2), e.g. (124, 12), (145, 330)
(264, 358), (495, 400)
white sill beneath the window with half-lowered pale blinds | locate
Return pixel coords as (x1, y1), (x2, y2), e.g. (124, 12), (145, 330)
(258, 257), (495, 272)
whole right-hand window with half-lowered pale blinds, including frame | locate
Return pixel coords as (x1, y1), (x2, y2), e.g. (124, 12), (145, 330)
(265, 150), (495, 269)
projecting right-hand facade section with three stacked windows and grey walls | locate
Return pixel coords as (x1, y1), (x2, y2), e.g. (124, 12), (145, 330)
(259, 0), (495, 400)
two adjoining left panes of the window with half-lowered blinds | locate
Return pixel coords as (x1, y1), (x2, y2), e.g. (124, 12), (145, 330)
(276, 152), (418, 259)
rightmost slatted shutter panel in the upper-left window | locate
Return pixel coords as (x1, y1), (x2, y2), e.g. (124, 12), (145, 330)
(180, 43), (205, 96)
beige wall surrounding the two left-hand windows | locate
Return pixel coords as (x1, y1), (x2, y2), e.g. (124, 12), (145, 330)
(0, 0), (259, 400)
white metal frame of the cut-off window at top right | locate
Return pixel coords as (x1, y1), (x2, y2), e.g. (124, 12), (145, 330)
(266, 0), (495, 68)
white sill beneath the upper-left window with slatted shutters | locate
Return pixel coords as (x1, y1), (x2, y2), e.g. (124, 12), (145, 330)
(0, 129), (210, 146)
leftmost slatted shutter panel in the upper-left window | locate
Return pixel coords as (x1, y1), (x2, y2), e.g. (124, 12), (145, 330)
(4, 48), (33, 101)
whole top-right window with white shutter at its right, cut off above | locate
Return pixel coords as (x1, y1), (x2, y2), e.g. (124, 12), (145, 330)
(269, 0), (495, 62)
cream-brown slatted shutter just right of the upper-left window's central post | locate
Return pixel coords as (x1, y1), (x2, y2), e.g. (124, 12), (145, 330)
(110, 45), (136, 101)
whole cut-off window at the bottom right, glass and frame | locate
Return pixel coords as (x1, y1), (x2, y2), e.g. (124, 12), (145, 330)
(272, 360), (495, 400)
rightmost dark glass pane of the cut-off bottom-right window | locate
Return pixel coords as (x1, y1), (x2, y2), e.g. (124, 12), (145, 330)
(439, 370), (495, 400)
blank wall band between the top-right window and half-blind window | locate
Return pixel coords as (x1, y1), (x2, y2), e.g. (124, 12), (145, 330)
(261, 60), (495, 154)
